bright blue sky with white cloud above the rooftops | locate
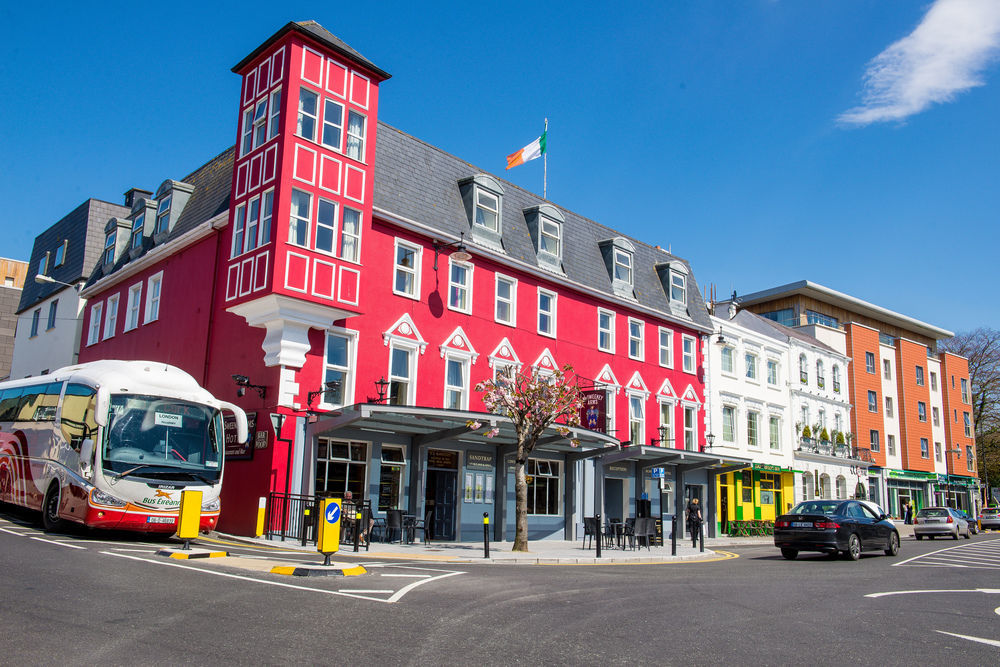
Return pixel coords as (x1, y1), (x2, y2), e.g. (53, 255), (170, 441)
(0, 0), (1000, 331)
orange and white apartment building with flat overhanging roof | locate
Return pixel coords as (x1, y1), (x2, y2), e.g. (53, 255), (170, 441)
(738, 280), (981, 516)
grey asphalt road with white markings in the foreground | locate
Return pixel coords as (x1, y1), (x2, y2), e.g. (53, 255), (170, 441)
(0, 507), (1000, 665)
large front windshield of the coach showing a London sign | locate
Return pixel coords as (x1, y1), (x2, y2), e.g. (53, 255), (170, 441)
(101, 394), (222, 484)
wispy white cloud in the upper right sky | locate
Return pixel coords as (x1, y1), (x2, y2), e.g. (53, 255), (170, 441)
(838, 0), (1000, 125)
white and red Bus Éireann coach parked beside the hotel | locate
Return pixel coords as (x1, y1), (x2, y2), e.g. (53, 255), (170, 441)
(0, 360), (247, 533)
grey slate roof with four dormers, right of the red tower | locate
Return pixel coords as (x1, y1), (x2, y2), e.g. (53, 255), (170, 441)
(374, 122), (712, 332)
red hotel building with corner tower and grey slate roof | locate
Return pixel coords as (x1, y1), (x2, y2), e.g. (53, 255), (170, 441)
(80, 22), (727, 540)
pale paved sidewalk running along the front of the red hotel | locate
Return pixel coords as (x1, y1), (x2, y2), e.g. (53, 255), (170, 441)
(214, 533), (773, 565)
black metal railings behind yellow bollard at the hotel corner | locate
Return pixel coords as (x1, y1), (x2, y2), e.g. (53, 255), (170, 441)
(264, 493), (374, 551)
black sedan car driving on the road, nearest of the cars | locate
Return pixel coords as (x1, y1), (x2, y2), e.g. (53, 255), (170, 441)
(774, 500), (899, 560)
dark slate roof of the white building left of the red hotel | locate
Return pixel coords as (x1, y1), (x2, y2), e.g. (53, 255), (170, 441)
(17, 199), (129, 313)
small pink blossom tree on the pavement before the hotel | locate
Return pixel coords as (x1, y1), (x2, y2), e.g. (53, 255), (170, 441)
(469, 365), (582, 551)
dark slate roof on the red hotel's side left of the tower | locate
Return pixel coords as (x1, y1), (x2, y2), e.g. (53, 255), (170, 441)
(87, 146), (236, 286)
